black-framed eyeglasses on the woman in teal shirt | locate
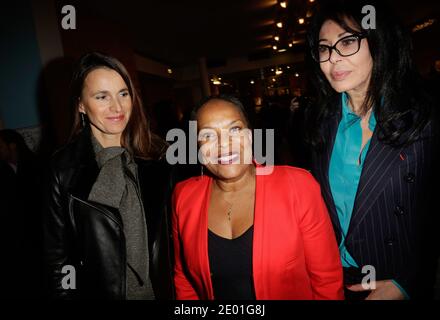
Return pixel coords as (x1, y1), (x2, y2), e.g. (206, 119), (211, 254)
(312, 34), (367, 63)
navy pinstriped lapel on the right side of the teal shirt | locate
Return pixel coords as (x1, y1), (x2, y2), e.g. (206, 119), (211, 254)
(347, 130), (402, 238)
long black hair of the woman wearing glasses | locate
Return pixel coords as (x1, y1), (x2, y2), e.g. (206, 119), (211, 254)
(306, 0), (430, 147)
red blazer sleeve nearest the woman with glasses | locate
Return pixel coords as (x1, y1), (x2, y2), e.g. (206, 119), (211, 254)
(296, 175), (344, 300)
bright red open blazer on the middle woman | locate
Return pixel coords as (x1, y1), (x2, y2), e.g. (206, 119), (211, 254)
(173, 166), (344, 300)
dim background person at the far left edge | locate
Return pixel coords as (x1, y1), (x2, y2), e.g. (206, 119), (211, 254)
(0, 129), (43, 298)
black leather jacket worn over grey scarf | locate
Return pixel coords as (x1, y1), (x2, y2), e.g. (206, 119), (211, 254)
(44, 129), (174, 299)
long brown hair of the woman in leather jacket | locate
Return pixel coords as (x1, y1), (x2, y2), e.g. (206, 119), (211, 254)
(70, 52), (166, 159)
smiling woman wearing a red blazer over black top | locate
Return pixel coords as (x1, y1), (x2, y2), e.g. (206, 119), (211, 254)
(173, 96), (343, 300)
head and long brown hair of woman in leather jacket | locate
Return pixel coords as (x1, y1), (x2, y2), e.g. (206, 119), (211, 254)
(70, 53), (166, 159)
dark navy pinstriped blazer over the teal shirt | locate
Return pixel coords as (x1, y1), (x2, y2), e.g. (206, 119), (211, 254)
(312, 104), (439, 297)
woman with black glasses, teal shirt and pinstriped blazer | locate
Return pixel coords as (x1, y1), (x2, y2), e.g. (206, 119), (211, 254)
(307, 0), (438, 299)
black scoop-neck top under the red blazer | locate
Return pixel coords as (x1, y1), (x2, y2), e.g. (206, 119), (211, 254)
(208, 226), (255, 300)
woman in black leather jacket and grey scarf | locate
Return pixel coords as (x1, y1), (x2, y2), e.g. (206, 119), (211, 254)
(44, 53), (173, 300)
